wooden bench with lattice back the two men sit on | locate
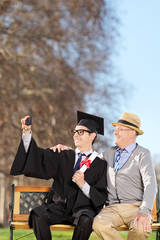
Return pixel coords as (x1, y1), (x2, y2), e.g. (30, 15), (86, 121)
(9, 184), (160, 240)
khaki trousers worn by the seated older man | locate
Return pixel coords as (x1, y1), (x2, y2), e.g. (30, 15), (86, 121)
(92, 202), (152, 240)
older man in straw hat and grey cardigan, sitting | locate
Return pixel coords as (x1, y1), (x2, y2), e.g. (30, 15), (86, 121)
(53, 112), (157, 240)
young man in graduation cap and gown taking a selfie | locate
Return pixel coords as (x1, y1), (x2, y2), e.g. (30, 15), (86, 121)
(10, 112), (107, 240)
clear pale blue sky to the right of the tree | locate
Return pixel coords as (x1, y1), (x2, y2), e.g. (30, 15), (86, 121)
(111, 0), (160, 161)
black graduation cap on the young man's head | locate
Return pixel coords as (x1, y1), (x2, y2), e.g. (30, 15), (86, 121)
(77, 111), (104, 135)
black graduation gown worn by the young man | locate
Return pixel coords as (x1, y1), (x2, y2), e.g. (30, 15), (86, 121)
(10, 138), (107, 227)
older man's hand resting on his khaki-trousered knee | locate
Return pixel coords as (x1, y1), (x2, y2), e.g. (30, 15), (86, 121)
(133, 213), (151, 232)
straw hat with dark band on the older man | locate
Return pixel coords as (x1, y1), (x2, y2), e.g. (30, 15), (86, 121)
(112, 112), (143, 135)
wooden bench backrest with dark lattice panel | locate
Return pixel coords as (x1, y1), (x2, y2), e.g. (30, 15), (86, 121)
(11, 184), (159, 222)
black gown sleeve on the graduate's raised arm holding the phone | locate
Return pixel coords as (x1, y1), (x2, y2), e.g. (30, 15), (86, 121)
(10, 138), (59, 179)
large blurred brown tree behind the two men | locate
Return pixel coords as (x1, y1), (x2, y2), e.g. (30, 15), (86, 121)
(0, 0), (123, 224)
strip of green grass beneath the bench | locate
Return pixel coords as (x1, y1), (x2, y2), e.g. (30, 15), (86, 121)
(0, 228), (156, 240)
